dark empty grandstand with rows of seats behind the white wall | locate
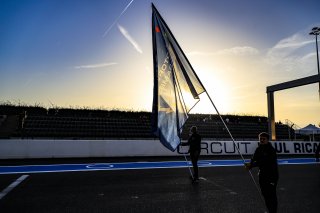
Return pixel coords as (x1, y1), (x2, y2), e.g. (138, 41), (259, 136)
(0, 104), (296, 140)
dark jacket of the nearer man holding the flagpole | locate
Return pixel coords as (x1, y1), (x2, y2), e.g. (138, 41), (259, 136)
(251, 143), (279, 183)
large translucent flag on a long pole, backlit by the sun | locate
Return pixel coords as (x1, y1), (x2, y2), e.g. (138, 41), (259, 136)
(152, 4), (205, 151)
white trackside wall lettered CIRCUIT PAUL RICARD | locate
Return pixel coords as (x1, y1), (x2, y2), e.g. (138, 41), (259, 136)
(0, 139), (318, 159)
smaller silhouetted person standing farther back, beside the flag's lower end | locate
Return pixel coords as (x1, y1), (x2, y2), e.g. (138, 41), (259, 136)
(181, 126), (201, 181)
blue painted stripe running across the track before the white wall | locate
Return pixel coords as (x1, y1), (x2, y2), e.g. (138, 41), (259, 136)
(0, 158), (317, 175)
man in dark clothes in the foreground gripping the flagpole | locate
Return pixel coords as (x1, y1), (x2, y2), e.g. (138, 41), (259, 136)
(245, 132), (279, 213)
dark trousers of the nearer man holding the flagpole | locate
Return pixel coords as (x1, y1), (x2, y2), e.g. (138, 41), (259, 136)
(259, 178), (278, 213)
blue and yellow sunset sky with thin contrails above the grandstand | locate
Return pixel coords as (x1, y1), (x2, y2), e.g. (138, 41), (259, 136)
(0, 0), (320, 127)
